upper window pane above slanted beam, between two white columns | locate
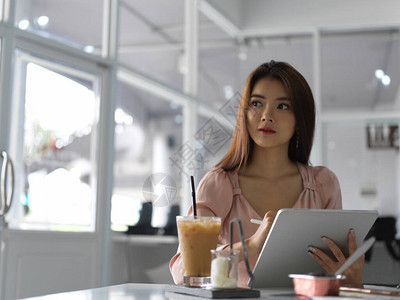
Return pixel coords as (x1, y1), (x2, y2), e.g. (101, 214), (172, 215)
(118, 0), (184, 90)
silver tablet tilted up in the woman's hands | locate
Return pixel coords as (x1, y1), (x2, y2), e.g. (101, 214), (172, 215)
(248, 208), (378, 288)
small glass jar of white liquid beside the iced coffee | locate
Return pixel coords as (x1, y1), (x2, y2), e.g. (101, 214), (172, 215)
(211, 249), (240, 289)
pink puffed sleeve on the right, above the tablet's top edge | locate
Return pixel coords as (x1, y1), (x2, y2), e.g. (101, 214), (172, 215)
(316, 167), (342, 209)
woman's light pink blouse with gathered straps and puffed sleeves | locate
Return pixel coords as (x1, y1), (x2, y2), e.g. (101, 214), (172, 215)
(169, 163), (342, 286)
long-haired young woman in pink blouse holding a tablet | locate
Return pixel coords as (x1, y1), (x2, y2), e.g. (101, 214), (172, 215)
(170, 61), (364, 286)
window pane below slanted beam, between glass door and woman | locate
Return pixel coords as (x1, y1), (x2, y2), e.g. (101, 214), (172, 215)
(111, 81), (183, 234)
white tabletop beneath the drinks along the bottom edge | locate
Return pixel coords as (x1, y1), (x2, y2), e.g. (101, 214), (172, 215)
(21, 283), (293, 300)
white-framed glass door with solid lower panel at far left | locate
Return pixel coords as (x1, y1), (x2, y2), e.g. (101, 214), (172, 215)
(0, 49), (109, 299)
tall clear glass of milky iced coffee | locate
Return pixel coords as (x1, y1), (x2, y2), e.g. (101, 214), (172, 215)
(176, 216), (221, 286)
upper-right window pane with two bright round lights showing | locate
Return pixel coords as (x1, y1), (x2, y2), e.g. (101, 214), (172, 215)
(321, 29), (400, 112)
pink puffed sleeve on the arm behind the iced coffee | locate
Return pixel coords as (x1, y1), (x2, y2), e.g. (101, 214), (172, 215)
(169, 168), (233, 285)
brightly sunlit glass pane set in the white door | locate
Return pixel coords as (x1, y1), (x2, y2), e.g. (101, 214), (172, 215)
(9, 51), (99, 231)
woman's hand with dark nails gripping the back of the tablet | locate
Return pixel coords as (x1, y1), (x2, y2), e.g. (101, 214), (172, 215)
(308, 229), (365, 287)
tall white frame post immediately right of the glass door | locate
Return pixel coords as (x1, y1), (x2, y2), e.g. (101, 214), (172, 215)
(96, 0), (119, 285)
